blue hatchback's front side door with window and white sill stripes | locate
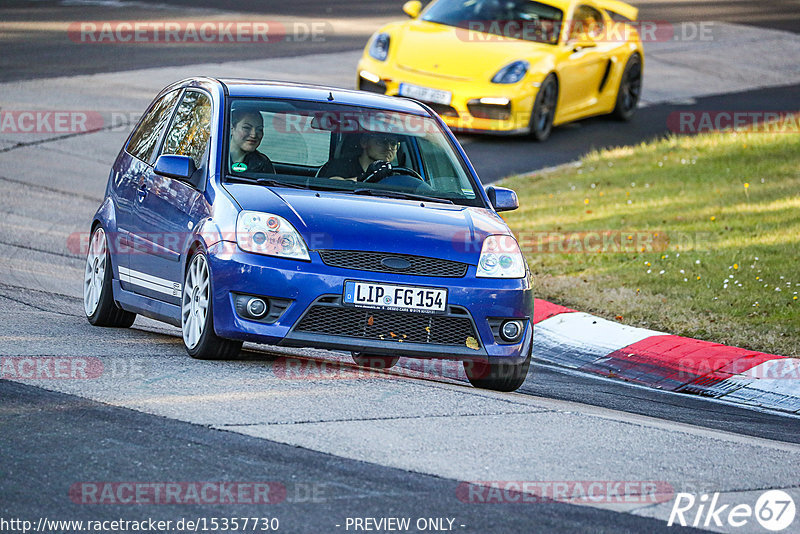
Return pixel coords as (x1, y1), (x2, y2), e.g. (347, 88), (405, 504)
(129, 89), (211, 304)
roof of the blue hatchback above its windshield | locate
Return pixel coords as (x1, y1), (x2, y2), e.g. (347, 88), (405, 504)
(218, 78), (429, 116)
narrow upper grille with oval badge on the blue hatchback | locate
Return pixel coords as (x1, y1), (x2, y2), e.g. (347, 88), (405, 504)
(318, 250), (468, 278)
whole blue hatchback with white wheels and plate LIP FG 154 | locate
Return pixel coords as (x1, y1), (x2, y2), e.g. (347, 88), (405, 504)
(84, 78), (533, 391)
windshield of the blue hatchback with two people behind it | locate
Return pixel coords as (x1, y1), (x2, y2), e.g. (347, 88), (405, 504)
(225, 98), (484, 206)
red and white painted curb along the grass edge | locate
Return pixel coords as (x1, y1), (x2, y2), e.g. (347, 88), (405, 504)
(533, 299), (800, 414)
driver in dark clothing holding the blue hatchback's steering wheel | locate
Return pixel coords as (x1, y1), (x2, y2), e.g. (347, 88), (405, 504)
(317, 133), (400, 182)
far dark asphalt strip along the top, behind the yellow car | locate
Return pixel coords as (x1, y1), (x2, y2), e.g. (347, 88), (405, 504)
(0, 0), (800, 81)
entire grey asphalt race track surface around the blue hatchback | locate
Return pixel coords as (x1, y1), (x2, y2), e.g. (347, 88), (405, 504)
(0, 0), (800, 533)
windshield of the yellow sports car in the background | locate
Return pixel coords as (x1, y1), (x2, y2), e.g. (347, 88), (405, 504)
(422, 0), (564, 44)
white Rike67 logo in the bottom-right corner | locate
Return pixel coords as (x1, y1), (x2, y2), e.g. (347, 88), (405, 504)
(667, 490), (796, 532)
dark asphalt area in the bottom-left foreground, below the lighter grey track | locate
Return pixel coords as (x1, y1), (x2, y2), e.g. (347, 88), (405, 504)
(0, 381), (708, 533)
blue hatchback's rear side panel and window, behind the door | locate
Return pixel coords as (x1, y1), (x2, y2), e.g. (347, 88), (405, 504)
(109, 89), (181, 291)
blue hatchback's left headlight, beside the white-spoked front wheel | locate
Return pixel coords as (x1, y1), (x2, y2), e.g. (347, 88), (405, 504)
(236, 210), (311, 261)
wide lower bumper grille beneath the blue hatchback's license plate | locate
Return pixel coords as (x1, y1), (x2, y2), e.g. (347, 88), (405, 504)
(295, 303), (480, 348)
